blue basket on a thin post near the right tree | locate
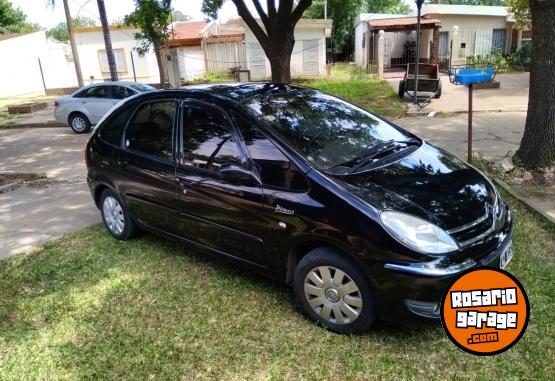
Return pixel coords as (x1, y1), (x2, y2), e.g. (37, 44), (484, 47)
(449, 65), (495, 163)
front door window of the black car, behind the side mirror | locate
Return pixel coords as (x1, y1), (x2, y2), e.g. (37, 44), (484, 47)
(183, 105), (241, 171)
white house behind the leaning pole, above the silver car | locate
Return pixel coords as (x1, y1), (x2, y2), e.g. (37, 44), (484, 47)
(75, 25), (160, 84)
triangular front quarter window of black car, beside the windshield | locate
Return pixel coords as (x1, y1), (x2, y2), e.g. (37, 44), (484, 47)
(233, 114), (308, 191)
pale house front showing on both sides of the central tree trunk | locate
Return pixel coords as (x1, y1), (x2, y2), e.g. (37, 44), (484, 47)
(245, 19), (332, 80)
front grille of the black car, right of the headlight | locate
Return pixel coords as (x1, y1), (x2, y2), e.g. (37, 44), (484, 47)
(447, 197), (503, 248)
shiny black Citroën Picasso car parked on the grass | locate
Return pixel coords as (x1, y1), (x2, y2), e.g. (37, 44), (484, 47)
(85, 84), (512, 332)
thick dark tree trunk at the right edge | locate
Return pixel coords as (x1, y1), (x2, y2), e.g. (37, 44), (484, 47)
(515, 0), (555, 169)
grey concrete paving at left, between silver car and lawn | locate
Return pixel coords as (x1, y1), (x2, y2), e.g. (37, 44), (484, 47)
(0, 127), (100, 259)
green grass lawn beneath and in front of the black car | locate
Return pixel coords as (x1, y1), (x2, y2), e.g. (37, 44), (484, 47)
(0, 193), (555, 380)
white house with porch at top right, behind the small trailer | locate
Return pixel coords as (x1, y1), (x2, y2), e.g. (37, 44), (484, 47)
(354, 4), (531, 67)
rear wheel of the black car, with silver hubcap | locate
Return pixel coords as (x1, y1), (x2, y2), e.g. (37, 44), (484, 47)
(99, 189), (138, 241)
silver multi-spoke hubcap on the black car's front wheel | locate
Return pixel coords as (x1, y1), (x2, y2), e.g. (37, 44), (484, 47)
(304, 266), (362, 324)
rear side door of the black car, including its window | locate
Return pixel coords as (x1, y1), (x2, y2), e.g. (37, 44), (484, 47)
(113, 99), (178, 234)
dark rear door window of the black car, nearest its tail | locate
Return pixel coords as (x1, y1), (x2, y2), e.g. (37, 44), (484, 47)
(125, 101), (176, 160)
